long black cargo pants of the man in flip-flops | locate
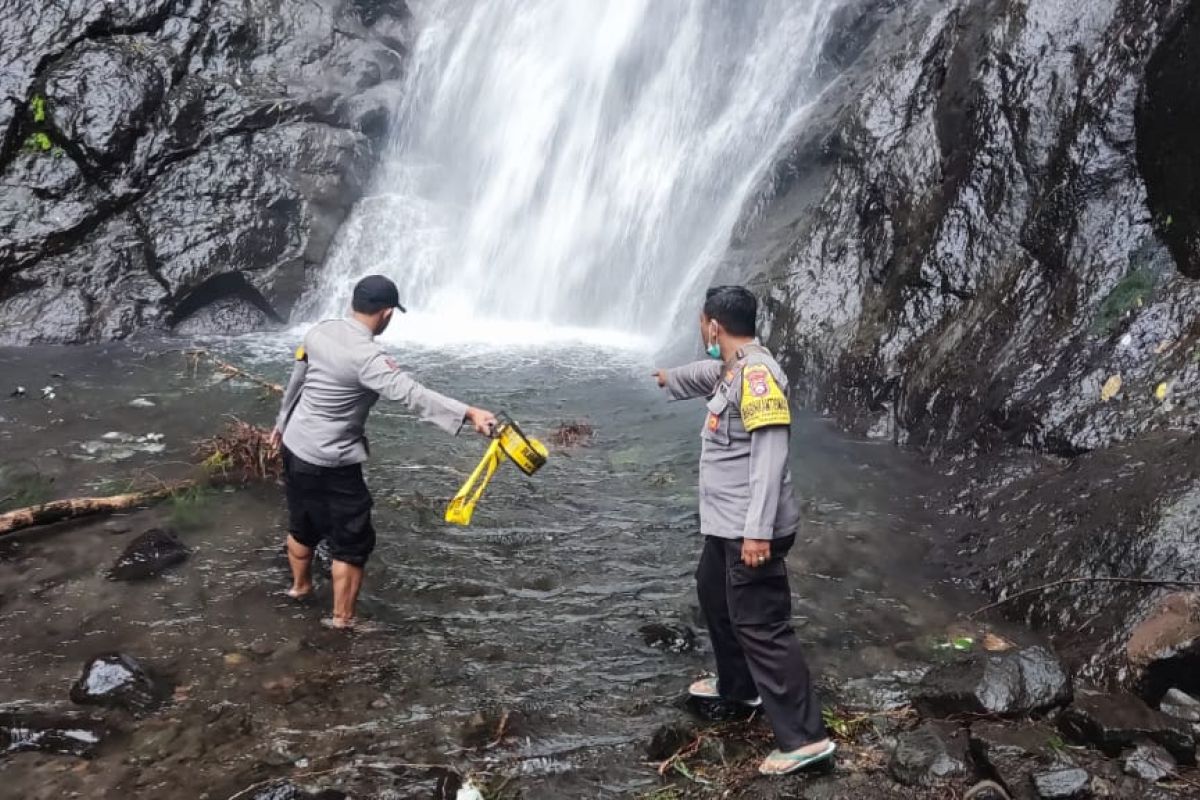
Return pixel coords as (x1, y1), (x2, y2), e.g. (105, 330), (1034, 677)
(696, 536), (826, 752)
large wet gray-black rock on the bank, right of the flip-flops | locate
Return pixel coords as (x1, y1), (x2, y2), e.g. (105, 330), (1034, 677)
(912, 646), (1070, 716)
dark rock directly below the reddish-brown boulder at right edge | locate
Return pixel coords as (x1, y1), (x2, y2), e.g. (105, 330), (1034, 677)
(1058, 692), (1196, 764)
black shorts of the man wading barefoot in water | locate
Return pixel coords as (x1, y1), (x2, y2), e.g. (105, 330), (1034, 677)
(283, 449), (374, 566)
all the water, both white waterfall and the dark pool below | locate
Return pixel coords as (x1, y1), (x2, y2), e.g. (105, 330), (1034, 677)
(0, 0), (1003, 799)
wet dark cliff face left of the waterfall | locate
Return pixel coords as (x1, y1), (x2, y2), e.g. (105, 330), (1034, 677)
(0, 0), (408, 344)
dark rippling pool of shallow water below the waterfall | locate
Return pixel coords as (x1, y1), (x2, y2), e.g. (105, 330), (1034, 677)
(0, 338), (1003, 798)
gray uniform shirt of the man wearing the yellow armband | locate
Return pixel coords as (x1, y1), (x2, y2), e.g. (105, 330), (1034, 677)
(666, 345), (800, 539)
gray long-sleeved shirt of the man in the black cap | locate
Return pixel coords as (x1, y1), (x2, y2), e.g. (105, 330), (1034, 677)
(275, 319), (467, 467)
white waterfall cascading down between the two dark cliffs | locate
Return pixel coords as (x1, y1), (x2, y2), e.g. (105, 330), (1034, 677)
(310, 0), (836, 339)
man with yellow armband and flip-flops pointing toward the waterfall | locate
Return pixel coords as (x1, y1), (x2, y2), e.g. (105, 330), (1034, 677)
(655, 287), (834, 775)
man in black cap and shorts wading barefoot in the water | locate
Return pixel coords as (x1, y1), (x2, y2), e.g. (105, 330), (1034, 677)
(272, 275), (496, 627)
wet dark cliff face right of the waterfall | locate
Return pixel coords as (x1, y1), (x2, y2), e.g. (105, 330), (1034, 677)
(733, 0), (1200, 679)
